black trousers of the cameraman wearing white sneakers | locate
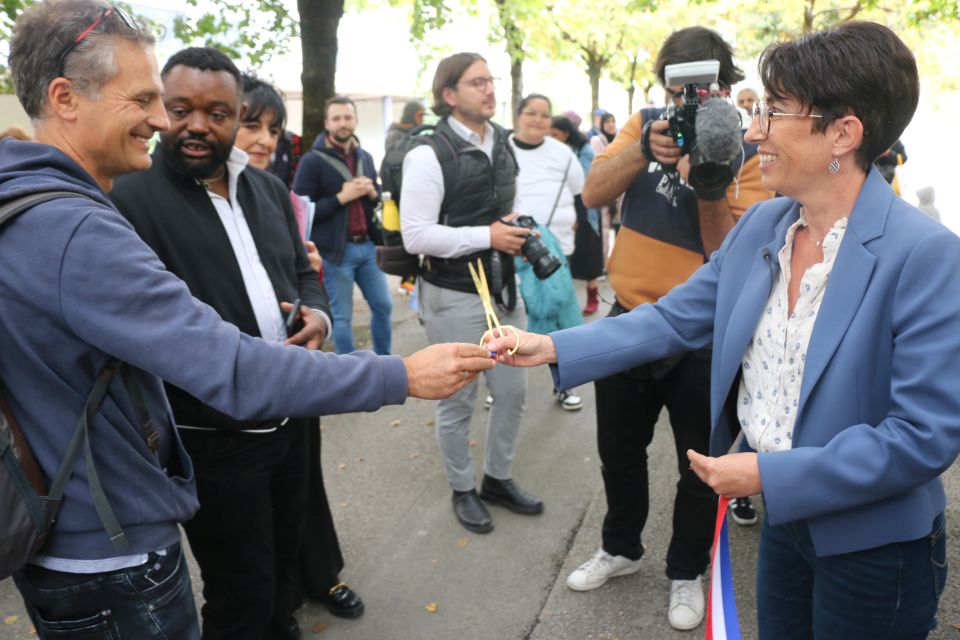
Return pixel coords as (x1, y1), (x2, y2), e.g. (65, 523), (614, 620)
(595, 306), (717, 580)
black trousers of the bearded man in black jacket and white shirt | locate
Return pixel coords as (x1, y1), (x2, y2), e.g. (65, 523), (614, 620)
(180, 419), (316, 640)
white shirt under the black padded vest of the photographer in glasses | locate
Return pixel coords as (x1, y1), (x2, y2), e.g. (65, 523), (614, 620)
(400, 116), (495, 258)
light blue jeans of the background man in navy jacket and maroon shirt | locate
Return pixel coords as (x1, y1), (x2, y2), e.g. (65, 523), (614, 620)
(323, 240), (393, 356)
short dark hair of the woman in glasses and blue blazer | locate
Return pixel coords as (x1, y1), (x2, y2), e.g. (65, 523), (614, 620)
(759, 21), (920, 171)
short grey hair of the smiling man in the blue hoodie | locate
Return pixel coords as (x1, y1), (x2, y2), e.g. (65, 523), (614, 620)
(9, 0), (156, 124)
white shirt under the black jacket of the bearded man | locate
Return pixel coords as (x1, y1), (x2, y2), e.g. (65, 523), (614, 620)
(207, 147), (292, 342)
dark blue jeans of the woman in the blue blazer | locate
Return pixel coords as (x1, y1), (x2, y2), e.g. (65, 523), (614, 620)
(757, 514), (947, 640)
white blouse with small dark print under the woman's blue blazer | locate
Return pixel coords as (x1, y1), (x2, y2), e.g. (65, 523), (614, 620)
(737, 210), (847, 451)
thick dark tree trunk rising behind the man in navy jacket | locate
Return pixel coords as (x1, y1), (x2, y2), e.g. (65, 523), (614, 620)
(297, 0), (344, 148)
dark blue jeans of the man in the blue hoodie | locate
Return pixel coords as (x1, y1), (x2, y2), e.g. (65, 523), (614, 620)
(13, 542), (200, 640)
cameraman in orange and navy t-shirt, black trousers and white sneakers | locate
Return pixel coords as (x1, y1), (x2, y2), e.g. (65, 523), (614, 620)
(567, 27), (772, 630)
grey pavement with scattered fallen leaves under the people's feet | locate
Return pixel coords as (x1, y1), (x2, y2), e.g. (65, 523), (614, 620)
(0, 283), (960, 640)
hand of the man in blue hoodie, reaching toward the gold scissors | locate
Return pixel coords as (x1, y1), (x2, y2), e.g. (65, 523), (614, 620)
(403, 342), (497, 400)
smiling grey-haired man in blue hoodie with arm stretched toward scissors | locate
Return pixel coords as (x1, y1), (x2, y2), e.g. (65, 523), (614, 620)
(0, 0), (493, 639)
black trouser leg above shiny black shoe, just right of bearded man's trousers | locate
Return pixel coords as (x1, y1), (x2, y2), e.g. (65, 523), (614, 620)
(294, 420), (343, 607)
